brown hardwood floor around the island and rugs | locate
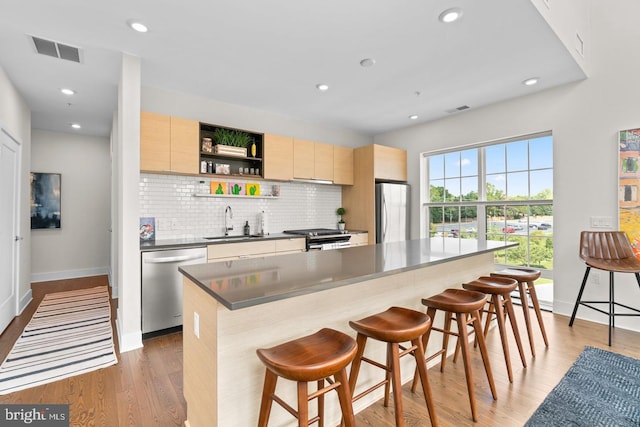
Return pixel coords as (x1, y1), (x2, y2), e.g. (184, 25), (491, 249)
(0, 276), (640, 427)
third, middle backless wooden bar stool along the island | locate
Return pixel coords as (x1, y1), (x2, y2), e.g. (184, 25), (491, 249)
(412, 289), (498, 421)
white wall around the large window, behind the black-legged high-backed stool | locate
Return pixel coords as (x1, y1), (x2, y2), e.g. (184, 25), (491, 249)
(375, 0), (640, 330)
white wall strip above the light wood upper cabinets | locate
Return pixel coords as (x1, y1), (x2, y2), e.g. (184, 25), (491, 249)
(141, 86), (373, 147)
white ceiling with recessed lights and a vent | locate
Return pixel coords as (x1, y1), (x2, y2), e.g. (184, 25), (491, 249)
(0, 0), (585, 136)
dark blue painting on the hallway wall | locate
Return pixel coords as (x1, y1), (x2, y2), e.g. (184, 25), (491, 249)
(31, 172), (61, 229)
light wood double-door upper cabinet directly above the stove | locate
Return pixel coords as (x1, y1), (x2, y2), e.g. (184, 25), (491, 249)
(293, 139), (333, 181)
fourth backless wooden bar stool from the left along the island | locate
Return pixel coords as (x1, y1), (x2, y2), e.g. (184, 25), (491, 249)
(456, 276), (527, 382)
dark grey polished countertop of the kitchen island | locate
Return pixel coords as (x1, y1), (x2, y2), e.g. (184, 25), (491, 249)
(178, 234), (517, 310)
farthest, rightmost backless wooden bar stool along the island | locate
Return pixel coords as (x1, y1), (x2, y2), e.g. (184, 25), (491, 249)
(491, 267), (549, 357)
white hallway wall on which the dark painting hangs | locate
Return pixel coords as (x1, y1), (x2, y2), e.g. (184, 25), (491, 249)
(30, 130), (111, 282)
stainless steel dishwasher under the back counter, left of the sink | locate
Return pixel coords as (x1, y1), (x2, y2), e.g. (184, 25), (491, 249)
(142, 247), (207, 338)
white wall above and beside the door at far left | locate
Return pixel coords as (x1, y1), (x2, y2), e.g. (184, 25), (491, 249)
(0, 67), (31, 312)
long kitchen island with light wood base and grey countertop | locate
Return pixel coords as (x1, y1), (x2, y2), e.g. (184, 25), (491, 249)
(180, 238), (516, 427)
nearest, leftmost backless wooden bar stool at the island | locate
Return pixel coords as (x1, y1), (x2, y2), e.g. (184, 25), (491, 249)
(256, 328), (357, 427)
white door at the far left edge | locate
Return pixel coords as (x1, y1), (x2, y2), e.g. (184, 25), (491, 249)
(0, 129), (19, 332)
